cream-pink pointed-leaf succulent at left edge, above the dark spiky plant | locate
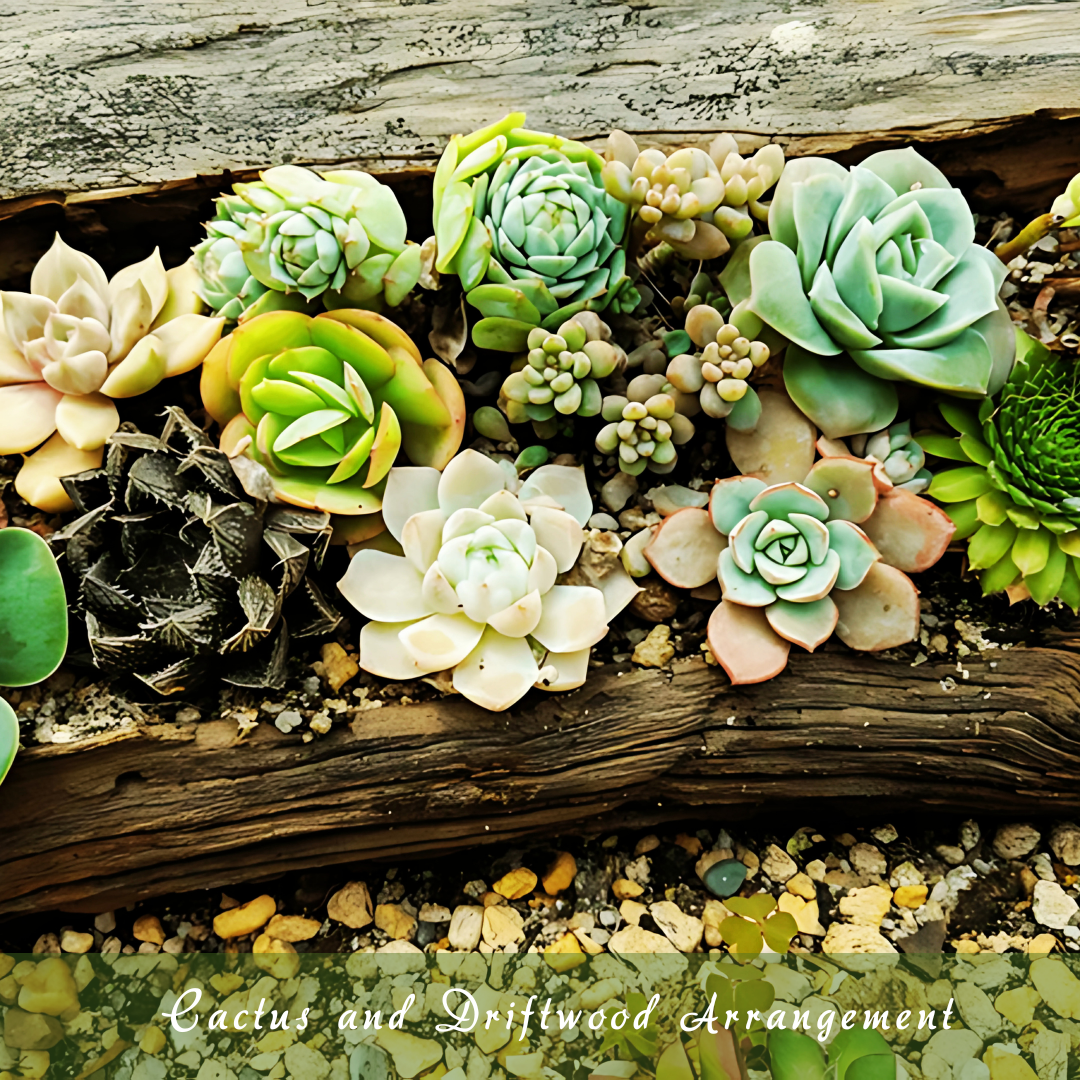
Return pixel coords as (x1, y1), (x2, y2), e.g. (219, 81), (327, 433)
(0, 235), (225, 513)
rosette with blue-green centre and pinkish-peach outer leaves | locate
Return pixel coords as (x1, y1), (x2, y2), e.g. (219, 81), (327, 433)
(645, 393), (954, 684)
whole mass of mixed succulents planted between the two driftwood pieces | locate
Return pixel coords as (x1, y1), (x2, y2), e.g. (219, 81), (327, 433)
(0, 112), (1080, 734)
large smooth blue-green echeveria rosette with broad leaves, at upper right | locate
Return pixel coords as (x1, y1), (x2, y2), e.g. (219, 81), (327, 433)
(738, 148), (1014, 438)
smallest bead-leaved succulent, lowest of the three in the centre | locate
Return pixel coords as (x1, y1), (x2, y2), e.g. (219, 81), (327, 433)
(596, 375), (693, 476)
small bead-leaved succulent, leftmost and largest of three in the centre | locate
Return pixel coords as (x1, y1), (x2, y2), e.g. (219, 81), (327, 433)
(499, 311), (626, 423)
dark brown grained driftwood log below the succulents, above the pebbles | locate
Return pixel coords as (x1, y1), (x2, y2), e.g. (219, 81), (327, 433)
(0, 633), (1080, 914)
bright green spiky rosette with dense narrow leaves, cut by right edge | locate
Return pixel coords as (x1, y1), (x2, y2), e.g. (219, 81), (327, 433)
(918, 332), (1080, 611)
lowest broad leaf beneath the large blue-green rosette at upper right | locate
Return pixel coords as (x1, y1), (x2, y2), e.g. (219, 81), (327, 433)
(784, 345), (900, 438)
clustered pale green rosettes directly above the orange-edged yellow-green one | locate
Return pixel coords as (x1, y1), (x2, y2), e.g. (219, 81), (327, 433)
(192, 165), (421, 320)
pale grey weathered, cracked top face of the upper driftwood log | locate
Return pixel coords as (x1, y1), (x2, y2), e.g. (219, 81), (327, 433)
(0, 0), (1080, 199)
